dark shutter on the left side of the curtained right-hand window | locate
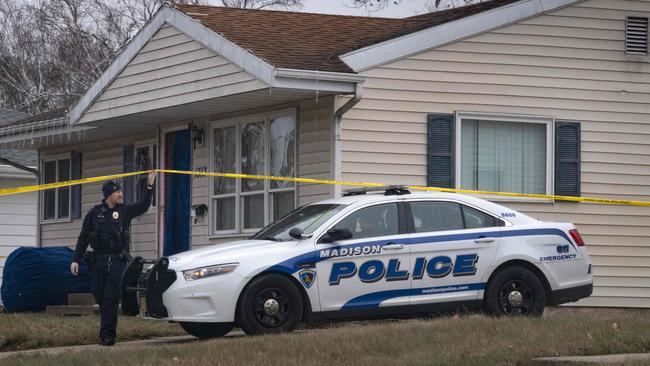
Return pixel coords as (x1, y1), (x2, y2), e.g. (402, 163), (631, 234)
(427, 114), (455, 188)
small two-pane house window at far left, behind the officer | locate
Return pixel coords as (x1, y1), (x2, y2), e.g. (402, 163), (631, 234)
(42, 155), (72, 221)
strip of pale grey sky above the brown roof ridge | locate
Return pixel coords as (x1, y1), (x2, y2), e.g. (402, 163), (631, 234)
(300, 0), (426, 18)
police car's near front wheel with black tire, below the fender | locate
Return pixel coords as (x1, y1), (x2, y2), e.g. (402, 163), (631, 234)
(238, 274), (303, 335)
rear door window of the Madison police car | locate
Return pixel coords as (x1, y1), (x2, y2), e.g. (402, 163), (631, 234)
(411, 201), (463, 233)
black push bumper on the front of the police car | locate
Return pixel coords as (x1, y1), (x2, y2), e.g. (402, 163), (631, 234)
(122, 257), (176, 319)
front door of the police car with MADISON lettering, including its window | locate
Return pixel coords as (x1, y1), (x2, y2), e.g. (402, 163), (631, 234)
(316, 201), (410, 318)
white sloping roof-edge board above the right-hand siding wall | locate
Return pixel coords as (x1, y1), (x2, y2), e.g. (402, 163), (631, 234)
(340, 0), (584, 72)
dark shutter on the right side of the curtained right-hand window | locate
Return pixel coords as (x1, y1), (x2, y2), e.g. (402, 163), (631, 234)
(555, 121), (580, 197)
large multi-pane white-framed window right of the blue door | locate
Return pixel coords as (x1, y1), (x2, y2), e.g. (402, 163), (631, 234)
(209, 110), (296, 235)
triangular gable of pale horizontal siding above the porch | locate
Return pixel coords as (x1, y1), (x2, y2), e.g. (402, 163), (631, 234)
(80, 25), (267, 123)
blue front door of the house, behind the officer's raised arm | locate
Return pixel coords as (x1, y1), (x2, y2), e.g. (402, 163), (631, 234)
(163, 130), (192, 256)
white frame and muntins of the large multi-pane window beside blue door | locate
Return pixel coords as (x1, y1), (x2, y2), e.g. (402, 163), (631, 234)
(207, 107), (299, 239)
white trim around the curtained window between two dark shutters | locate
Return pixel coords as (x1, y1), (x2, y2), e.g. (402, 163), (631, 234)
(454, 112), (555, 202)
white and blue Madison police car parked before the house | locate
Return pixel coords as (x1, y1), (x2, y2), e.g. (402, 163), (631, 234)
(122, 187), (593, 338)
